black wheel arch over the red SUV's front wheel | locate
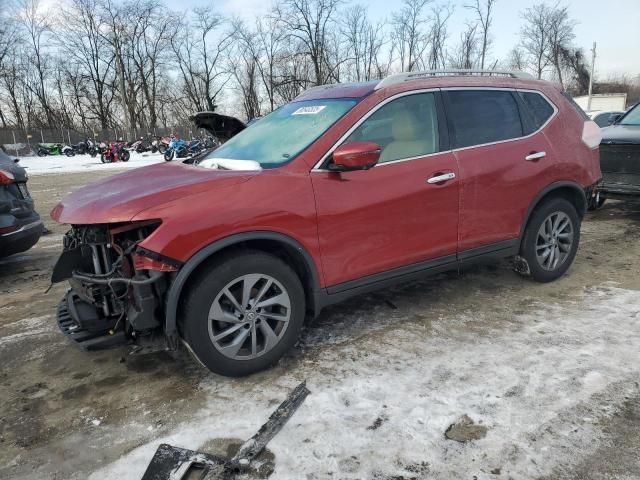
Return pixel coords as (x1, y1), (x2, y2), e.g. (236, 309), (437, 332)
(165, 231), (322, 338)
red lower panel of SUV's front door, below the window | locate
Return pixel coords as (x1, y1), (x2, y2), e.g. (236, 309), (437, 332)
(312, 153), (459, 285)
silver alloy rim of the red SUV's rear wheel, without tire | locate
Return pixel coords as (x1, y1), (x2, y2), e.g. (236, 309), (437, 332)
(536, 212), (574, 271)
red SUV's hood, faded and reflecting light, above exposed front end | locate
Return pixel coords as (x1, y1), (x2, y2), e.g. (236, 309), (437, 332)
(51, 159), (259, 225)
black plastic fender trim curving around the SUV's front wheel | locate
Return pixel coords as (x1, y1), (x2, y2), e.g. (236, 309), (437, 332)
(165, 231), (321, 339)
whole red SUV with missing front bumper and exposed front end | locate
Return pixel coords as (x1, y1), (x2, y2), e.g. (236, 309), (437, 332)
(52, 71), (601, 376)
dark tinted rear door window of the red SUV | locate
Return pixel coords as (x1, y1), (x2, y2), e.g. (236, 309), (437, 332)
(446, 90), (523, 148)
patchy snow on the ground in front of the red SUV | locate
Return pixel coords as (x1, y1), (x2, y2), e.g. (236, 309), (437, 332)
(91, 287), (640, 480)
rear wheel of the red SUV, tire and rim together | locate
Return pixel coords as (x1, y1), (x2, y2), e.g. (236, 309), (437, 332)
(520, 198), (581, 283)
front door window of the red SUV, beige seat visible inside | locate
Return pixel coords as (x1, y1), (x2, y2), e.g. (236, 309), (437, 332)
(344, 93), (439, 163)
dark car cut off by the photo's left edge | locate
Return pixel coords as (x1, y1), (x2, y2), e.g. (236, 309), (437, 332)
(0, 149), (44, 258)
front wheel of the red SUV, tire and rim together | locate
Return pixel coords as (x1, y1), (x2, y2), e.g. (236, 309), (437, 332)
(182, 251), (306, 377)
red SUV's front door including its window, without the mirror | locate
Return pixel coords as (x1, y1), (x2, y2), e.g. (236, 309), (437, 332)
(311, 92), (459, 291)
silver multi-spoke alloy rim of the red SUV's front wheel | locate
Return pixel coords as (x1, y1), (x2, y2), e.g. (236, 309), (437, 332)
(208, 274), (291, 360)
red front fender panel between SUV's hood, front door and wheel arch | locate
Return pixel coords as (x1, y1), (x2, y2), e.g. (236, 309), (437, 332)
(134, 169), (320, 265)
